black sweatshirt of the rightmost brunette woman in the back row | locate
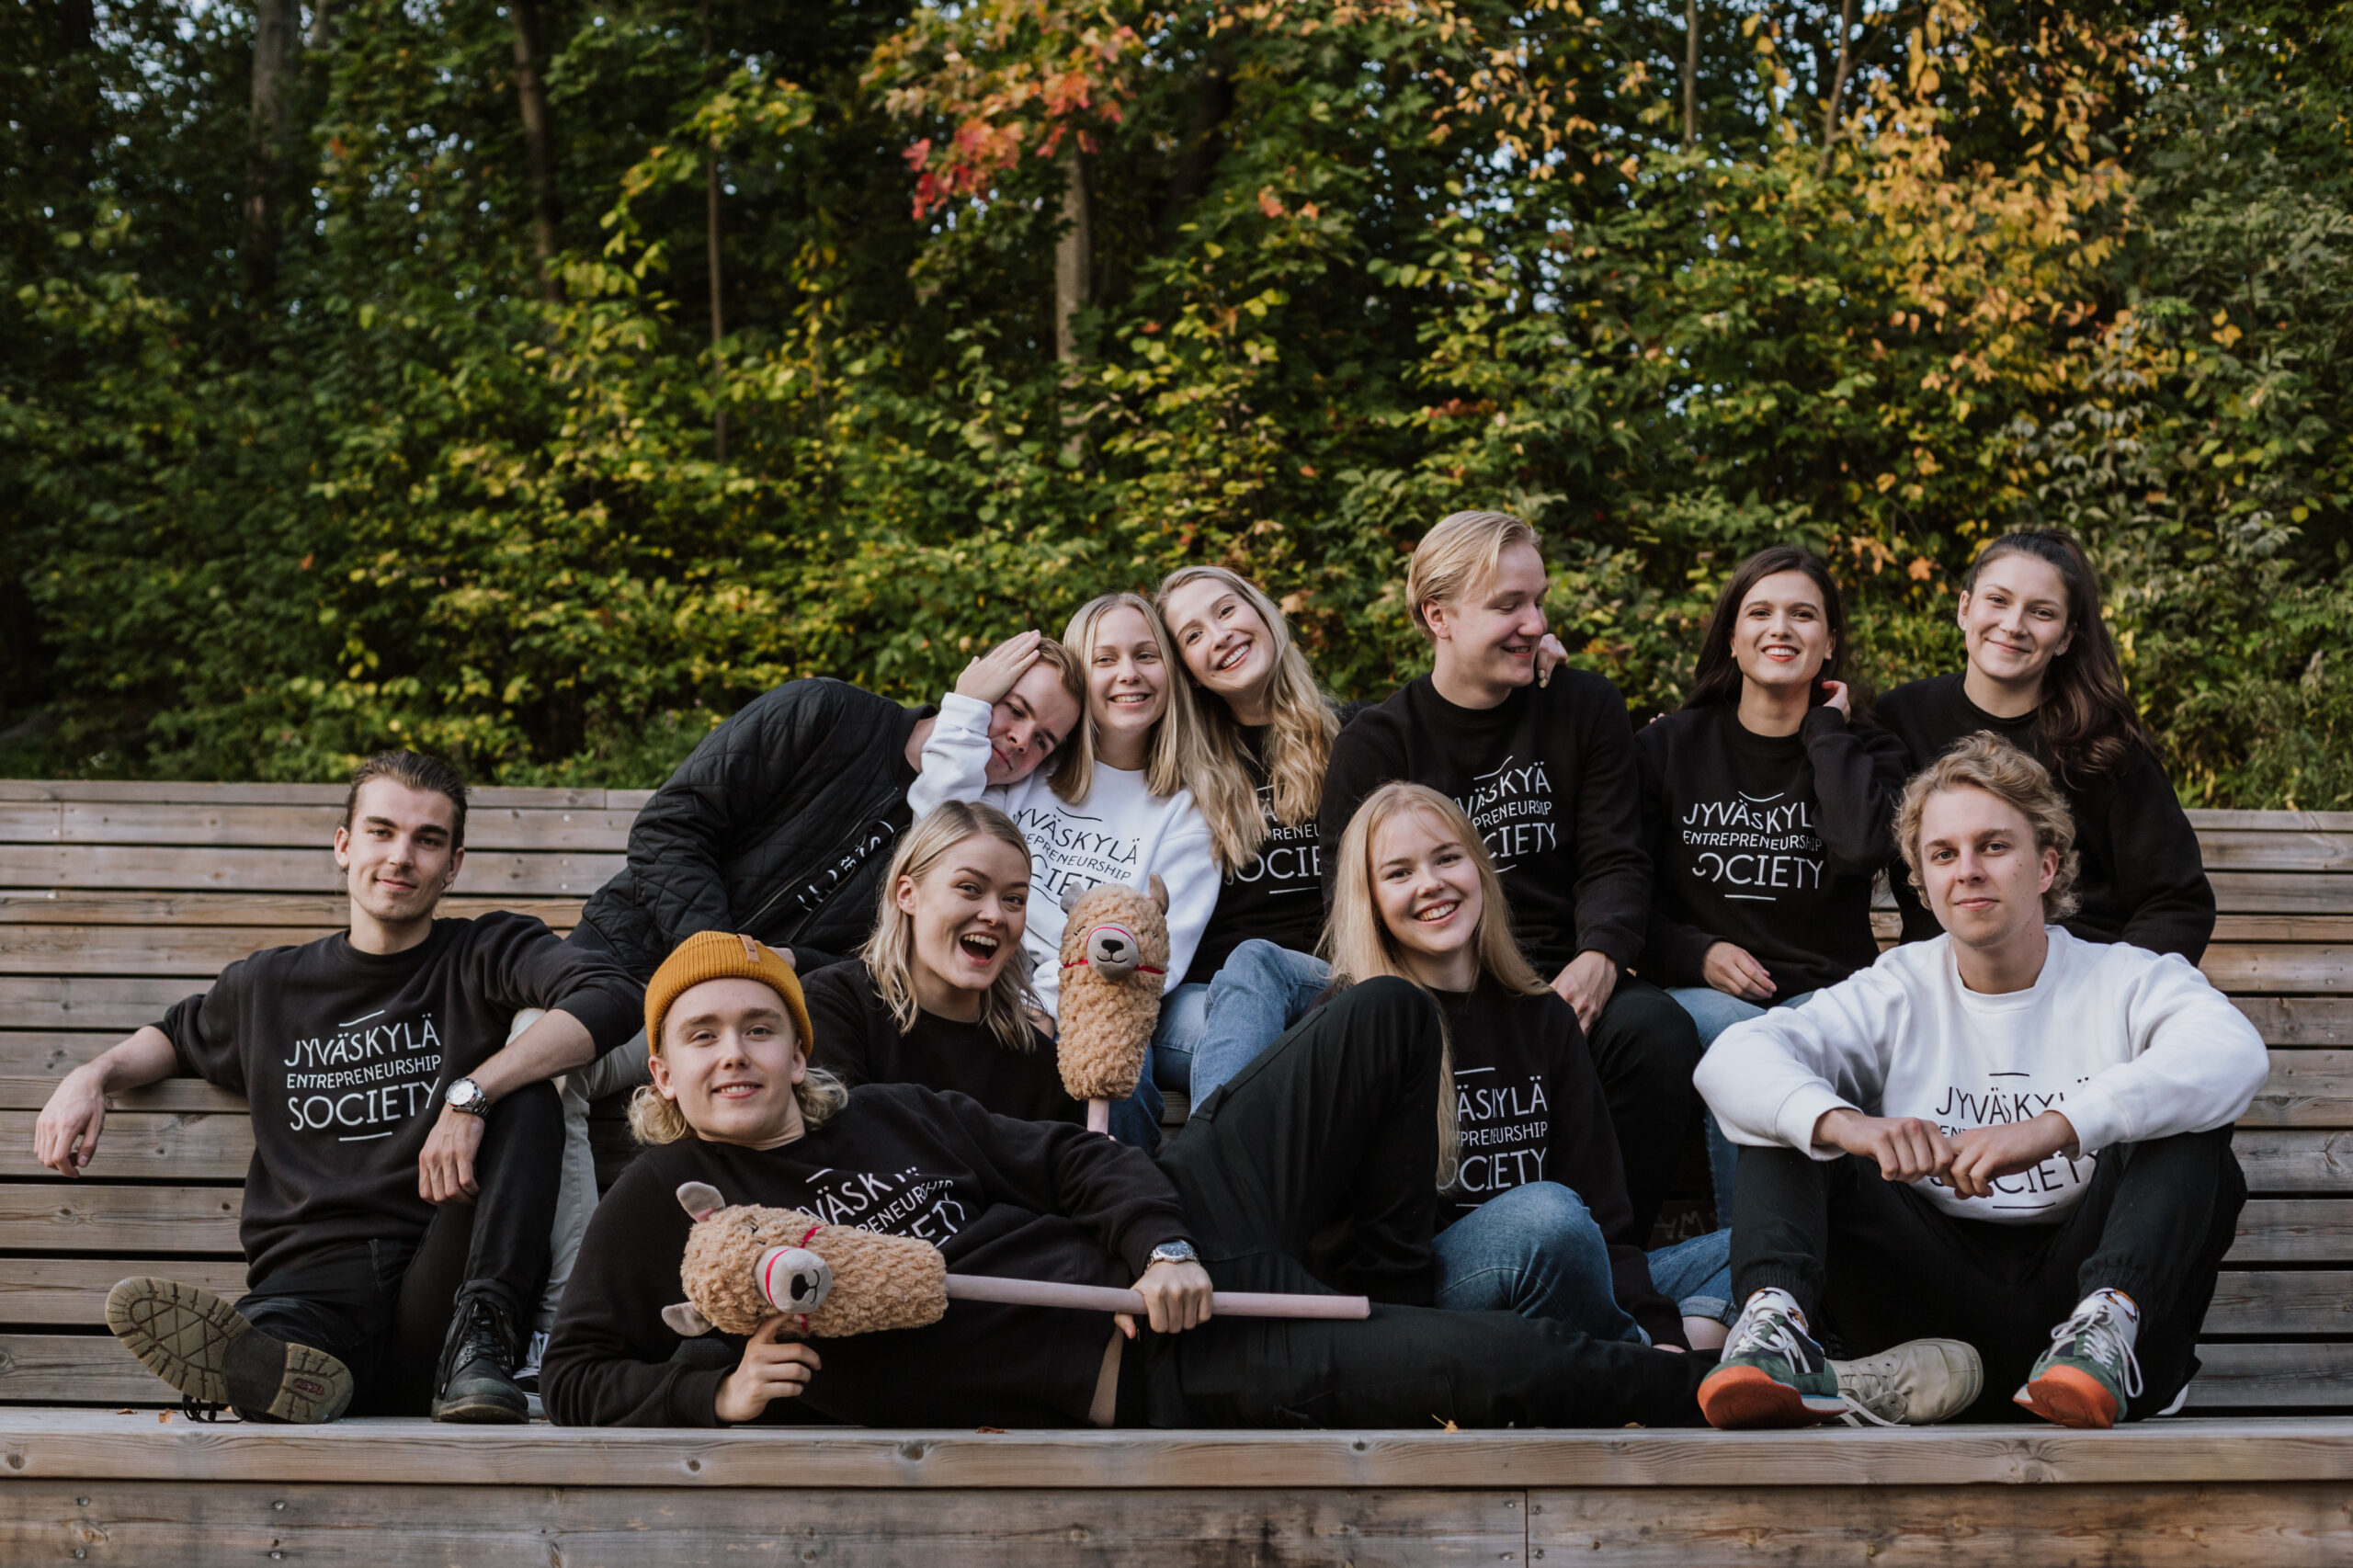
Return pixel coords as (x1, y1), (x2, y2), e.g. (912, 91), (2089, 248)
(1878, 676), (2214, 963)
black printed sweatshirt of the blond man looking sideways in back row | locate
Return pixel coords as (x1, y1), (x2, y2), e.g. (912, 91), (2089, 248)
(1320, 668), (1650, 980)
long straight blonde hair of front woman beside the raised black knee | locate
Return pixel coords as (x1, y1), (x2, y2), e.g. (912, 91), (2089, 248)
(1318, 784), (1546, 1189)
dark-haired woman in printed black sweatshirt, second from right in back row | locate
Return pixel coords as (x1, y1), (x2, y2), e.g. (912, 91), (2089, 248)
(1635, 546), (1906, 1221)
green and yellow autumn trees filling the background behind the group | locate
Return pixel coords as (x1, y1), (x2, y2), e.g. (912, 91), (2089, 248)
(0, 0), (2353, 808)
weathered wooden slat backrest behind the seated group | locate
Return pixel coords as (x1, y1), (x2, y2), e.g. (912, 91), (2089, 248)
(0, 779), (2353, 1410)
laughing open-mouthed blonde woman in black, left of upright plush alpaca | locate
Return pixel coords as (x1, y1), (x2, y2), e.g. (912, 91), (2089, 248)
(802, 801), (1087, 1123)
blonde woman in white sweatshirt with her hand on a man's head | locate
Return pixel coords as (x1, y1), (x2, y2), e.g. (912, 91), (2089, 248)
(908, 594), (1219, 1149)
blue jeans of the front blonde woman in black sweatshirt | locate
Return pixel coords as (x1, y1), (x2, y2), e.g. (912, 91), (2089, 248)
(1436, 1182), (1736, 1345)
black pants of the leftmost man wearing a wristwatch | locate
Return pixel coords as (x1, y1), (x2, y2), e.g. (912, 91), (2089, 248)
(238, 1083), (564, 1415)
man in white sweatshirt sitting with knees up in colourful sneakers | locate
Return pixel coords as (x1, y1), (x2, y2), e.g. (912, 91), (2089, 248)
(1699, 734), (2268, 1426)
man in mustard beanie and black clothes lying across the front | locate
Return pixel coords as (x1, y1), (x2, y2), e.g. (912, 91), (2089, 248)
(541, 932), (1957, 1426)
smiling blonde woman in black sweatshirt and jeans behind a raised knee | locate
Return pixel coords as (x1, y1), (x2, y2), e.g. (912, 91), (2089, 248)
(1323, 784), (1732, 1346)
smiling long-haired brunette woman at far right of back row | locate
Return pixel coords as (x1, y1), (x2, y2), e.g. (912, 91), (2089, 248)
(1878, 529), (2214, 963)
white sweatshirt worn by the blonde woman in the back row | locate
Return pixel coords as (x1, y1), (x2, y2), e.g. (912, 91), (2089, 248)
(906, 692), (1223, 1012)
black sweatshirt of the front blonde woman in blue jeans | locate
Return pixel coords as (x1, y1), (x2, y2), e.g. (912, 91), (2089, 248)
(1430, 980), (1685, 1345)
